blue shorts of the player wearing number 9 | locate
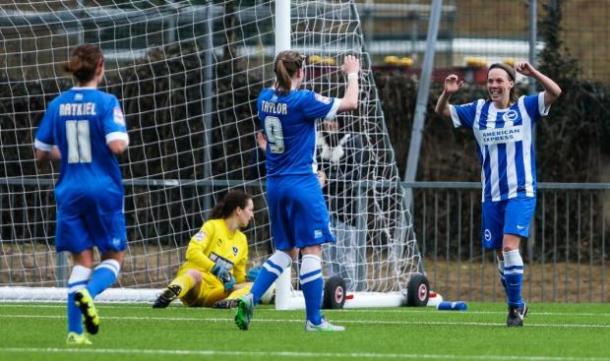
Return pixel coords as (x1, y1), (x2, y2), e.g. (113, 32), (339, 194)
(267, 173), (335, 251)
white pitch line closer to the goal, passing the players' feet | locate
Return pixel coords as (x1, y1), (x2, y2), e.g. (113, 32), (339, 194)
(0, 314), (610, 329)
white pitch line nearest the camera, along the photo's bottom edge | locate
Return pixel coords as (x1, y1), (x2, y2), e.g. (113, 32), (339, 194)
(0, 347), (610, 361)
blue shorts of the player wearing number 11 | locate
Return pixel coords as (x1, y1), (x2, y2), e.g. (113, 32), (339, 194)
(55, 194), (127, 254)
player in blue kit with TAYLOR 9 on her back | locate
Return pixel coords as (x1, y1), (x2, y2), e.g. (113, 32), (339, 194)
(235, 50), (360, 331)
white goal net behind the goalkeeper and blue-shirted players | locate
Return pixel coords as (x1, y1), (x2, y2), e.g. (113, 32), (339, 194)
(0, 0), (421, 301)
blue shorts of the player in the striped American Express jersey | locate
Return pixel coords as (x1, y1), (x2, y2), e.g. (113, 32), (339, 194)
(481, 197), (536, 249)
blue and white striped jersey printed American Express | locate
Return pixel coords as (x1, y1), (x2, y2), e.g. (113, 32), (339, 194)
(450, 92), (550, 202)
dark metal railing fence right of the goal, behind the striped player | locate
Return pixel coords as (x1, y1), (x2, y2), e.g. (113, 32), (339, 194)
(406, 182), (610, 302)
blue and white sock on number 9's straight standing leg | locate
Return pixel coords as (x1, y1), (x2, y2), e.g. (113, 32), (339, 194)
(299, 254), (324, 325)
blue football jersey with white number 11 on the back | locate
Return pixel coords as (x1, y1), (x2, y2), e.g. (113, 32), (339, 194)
(34, 87), (129, 207)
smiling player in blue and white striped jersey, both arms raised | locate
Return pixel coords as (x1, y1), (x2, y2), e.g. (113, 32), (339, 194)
(436, 62), (561, 327)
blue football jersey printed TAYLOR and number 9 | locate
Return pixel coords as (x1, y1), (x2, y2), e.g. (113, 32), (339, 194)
(257, 88), (340, 177)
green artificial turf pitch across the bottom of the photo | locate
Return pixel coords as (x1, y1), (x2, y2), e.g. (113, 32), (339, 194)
(0, 303), (610, 361)
